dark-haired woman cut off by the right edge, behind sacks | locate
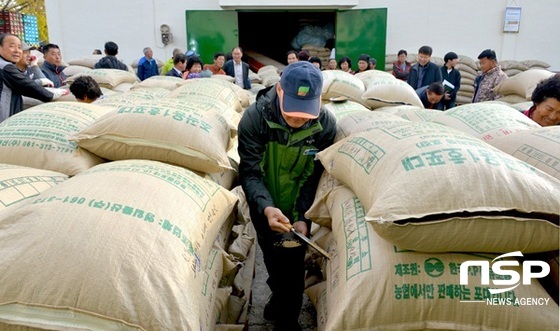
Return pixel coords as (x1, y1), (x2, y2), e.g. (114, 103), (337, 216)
(524, 74), (560, 126)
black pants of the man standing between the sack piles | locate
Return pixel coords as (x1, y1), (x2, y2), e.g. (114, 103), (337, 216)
(251, 213), (307, 321)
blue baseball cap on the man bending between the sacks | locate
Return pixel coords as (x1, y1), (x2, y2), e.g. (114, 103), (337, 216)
(280, 61), (323, 119)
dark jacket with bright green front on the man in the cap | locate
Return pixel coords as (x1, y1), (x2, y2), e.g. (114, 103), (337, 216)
(238, 86), (336, 226)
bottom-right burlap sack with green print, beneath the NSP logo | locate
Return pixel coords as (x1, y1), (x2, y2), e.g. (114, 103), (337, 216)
(307, 186), (559, 331)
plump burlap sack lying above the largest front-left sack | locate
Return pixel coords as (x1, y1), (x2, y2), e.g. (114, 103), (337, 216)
(73, 99), (236, 173)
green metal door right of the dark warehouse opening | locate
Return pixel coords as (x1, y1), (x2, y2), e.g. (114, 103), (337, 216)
(336, 8), (387, 71)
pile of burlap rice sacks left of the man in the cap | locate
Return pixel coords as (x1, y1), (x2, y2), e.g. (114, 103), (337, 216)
(0, 76), (256, 330)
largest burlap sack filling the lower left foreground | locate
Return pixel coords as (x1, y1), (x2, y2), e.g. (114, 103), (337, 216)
(0, 160), (236, 330)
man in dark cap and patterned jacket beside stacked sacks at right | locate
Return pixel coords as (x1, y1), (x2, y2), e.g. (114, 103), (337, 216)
(473, 49), (507, 102)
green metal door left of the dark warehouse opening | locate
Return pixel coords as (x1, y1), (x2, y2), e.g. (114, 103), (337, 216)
(185, 10), (239, 64)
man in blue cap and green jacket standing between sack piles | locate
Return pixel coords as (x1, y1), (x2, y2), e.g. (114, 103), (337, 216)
(238, 61), (336, 330)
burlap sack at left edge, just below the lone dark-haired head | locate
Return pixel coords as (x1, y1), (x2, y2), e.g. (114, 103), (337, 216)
(0, 102), (111, 176)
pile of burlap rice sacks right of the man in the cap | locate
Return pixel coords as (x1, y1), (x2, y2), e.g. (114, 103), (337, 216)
(296, 100), (560, 330)
